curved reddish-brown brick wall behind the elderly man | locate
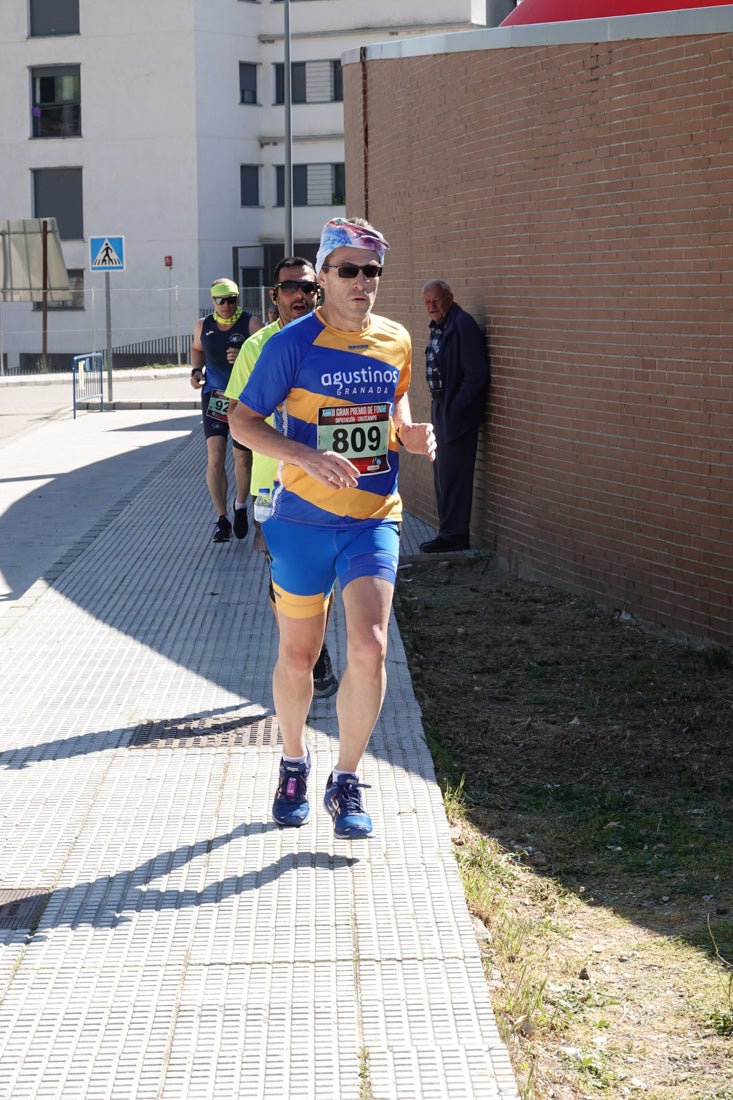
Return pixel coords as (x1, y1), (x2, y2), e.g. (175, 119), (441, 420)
(344, 34), (733, 645)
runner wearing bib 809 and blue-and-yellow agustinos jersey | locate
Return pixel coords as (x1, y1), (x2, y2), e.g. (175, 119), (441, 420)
(230, 218), (435, 838)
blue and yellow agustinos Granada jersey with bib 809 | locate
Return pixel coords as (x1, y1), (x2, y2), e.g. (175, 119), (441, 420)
(239, 309), (412, 527)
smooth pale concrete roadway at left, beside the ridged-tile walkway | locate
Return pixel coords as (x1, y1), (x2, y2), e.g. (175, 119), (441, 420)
(0, 370), (197, 630)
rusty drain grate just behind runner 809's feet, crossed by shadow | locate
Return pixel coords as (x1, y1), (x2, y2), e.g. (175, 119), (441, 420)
(130, 714), (282, 749)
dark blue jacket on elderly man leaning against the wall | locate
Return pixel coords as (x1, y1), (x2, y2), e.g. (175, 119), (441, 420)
(424, 303), (489, 443)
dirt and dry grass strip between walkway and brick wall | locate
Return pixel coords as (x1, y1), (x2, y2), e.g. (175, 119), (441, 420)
(395, 554), (733, 1100)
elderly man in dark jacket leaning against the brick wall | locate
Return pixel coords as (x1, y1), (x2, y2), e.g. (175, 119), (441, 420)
(420, 279), (489, 553)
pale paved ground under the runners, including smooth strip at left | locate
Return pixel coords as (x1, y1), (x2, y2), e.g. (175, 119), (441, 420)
(0, 393), (517, 1100)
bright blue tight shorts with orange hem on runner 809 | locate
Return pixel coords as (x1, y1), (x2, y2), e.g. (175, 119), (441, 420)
(262, 517), (400, 618)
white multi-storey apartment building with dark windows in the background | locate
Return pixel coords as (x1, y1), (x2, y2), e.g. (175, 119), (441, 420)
(0, 0), (514, 371)
